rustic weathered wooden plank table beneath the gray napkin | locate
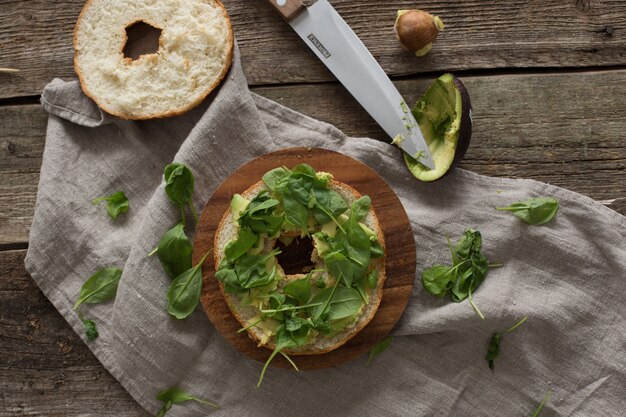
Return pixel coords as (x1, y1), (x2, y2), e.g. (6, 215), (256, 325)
(0, 0), (626, 417)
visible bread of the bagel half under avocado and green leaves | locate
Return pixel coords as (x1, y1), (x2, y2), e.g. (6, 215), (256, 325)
(214, 167), (385, 355)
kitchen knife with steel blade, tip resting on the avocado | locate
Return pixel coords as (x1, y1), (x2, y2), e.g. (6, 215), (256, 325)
(268, 0), (435, 169)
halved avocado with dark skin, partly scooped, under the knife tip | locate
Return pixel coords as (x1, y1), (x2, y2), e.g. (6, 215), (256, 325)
(404, 74), (472, 181)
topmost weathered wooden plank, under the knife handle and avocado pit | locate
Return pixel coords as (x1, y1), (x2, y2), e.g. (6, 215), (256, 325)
(0, 0), (626, 98)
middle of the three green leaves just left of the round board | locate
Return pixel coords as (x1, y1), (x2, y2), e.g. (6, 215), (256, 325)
(156, 222), (193, 278)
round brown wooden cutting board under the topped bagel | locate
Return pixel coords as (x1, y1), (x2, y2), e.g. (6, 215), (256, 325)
(193, 148), (416, 369)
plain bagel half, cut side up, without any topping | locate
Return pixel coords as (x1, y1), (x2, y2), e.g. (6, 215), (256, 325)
(74, 0), (233, 120)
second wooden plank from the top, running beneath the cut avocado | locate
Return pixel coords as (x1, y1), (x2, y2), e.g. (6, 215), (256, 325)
(0, 71), (626, 244)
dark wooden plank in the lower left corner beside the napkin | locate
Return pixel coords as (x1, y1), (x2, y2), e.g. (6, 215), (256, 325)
(0, 250), (149, 417)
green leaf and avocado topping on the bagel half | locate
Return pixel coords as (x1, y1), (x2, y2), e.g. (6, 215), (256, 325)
(215, 164), (384, 356)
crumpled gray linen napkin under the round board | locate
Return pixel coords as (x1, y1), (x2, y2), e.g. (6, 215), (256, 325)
(26, 45), (626, 417)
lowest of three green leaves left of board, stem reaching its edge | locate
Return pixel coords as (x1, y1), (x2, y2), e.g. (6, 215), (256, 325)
(167, 251), (211, 320)
